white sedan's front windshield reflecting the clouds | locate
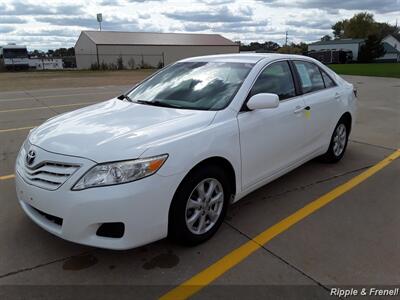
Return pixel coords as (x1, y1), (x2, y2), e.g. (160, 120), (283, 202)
(128, 62), (253, 110)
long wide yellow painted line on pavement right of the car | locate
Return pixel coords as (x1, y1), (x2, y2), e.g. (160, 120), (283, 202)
(160, 149), (400, 300)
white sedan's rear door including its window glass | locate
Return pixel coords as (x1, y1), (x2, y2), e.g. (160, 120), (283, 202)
(293, 60), (341, 153)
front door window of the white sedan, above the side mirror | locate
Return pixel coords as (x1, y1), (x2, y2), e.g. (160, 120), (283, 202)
(250, 61), (296, 100)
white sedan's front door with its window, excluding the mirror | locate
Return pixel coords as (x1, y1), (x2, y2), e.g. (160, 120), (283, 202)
(238, 61), (306, 189)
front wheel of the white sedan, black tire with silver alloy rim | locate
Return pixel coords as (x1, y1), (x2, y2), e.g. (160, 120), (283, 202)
(168, 165), (231, 246)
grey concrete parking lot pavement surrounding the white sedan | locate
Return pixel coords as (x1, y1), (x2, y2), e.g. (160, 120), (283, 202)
(0, 72), (400, 299)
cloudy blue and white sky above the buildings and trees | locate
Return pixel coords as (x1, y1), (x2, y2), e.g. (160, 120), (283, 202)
(0, 0), (400, 50)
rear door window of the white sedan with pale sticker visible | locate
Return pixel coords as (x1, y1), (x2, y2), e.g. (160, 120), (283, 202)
(294, 61), (325, 93)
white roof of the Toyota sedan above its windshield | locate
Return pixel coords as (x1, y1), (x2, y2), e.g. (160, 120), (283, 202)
(180, 53), (313, 64)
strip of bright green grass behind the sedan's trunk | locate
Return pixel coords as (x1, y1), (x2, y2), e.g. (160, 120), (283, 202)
(329, 63), (400, 78)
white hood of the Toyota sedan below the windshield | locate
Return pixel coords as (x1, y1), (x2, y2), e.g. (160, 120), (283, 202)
(29, 99), (216, 162)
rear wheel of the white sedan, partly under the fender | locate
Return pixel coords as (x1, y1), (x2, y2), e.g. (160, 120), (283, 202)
(320, 118), (350, 163)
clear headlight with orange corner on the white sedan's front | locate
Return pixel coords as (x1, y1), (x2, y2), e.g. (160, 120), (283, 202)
(72, 154), (168, 190)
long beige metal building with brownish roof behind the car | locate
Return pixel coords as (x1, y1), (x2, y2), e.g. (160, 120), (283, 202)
(75, 31), (239, 69)
